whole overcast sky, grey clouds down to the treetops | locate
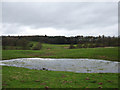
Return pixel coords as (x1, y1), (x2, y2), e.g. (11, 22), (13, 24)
(0, 2), (118, 36)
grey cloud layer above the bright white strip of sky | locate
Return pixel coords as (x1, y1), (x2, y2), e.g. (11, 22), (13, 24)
(2, 2), (118, 35)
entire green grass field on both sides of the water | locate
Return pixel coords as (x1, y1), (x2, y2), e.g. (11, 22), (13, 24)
(2, 42), (120, 88)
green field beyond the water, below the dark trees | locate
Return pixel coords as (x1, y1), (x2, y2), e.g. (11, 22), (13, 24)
(2, 43), (118, 61)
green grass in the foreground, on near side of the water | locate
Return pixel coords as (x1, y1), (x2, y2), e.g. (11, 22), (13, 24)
(2, 66), (118, 88)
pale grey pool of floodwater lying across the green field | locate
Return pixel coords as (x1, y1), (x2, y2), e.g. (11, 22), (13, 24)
(0, 58), (120, 73)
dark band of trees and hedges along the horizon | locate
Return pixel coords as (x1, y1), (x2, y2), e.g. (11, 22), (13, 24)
(2, 35), (120, 49)
